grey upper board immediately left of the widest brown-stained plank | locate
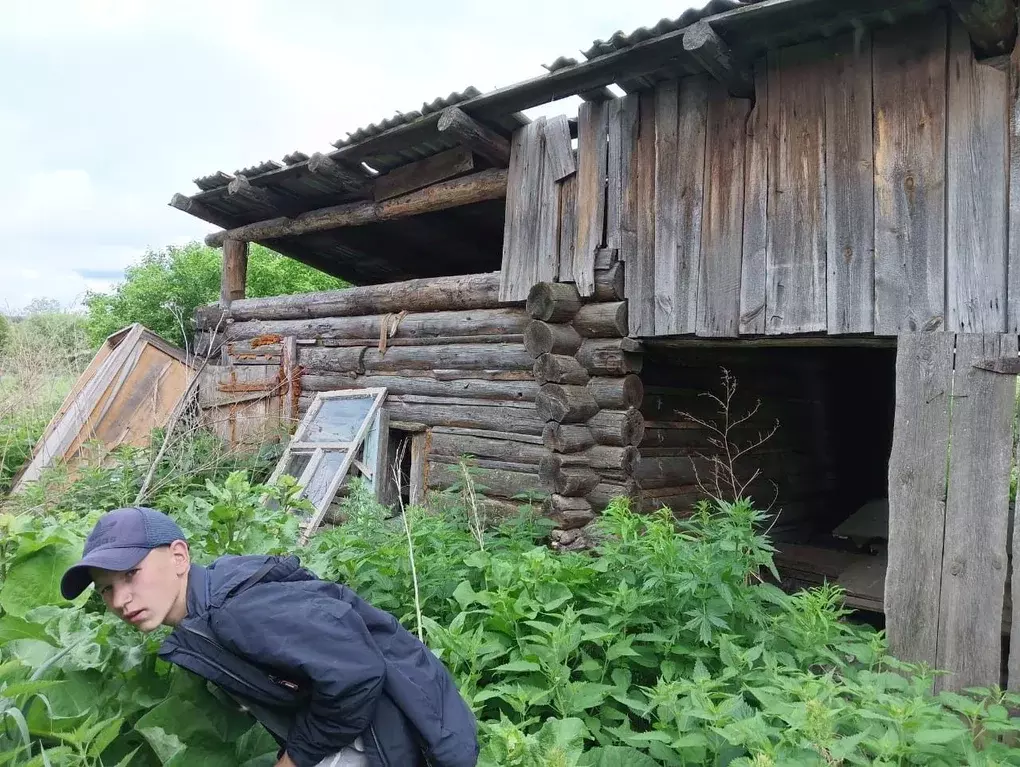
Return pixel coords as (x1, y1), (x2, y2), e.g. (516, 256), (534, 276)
(822, 35), (875, 336)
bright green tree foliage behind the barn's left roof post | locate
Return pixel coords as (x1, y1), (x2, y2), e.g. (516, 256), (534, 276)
(86, 243), (347, 346)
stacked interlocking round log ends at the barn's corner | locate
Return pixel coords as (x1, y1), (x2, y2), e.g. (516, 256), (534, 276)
(524, 261), (645, 548)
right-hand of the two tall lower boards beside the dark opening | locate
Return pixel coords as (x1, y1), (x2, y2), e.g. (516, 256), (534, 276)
(935, 334), (1017, 692)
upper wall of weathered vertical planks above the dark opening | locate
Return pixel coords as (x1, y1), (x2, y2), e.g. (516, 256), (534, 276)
(495, 11), (1020, 338)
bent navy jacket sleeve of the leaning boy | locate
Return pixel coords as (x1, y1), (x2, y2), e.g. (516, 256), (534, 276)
(212, 583), (386, 767)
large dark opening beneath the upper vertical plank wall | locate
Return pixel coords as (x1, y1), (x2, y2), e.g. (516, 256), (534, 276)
(636, 339), (896, 613)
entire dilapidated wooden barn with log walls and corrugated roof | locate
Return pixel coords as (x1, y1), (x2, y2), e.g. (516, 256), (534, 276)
(171, 0), (1020, 688)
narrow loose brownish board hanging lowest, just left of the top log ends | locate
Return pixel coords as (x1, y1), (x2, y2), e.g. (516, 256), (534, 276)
(573, 101), (608, 297)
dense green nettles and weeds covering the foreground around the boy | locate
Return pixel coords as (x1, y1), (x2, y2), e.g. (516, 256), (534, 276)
(0, 440), (1020, 767)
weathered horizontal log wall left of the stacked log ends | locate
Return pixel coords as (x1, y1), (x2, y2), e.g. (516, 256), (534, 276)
(198, 273), (550, 516)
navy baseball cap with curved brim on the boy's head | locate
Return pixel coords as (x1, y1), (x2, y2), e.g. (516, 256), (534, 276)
(60, 506), (186, 600)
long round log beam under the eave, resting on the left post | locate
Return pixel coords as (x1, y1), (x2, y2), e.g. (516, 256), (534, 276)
(205, 168), (507, 247)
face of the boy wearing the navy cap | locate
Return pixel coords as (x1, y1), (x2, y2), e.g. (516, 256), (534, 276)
(91, 541), (191, 633)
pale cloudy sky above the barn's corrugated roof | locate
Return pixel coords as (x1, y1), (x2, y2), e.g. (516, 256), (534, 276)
(0, 0), (703, 312)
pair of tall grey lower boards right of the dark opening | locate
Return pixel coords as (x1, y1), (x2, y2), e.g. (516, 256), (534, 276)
(885, 331), (1018, 689)
